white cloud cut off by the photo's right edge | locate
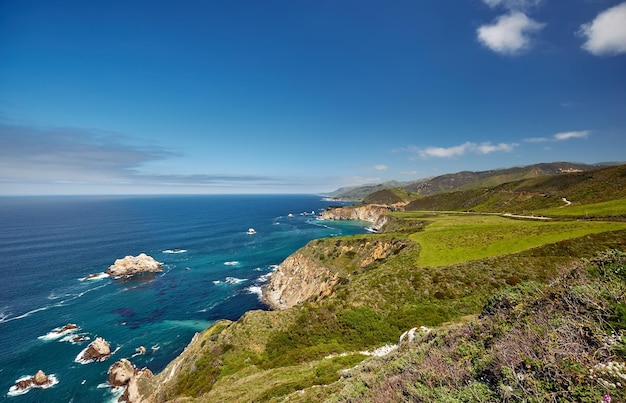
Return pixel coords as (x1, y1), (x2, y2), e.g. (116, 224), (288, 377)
(578, 2), (626, 56)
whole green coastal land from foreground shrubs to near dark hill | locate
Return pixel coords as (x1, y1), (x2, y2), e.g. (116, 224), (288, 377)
(140, 166), (626, 402)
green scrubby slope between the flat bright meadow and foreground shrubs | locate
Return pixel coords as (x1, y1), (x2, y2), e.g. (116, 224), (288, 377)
(145, 214), (626, 401)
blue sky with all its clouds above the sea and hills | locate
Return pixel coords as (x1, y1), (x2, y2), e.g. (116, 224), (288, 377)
(0, 0), (626, 195)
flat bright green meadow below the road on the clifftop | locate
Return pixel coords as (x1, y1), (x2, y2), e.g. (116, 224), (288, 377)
(410, 214), (626, 266)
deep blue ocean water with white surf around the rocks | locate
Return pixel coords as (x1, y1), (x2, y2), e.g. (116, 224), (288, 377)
(0, 195), (367, 403)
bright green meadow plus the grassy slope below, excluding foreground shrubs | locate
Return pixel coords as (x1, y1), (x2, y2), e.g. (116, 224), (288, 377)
(157, 212), (626, 401)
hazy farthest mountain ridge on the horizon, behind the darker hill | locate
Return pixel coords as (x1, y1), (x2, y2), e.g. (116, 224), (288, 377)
(325, 162), (616, 201)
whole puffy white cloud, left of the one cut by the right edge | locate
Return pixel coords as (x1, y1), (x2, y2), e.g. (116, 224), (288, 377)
(476, 11), (545, 55)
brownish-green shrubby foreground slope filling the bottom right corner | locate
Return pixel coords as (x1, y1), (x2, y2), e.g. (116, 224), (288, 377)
(322, 250), (626, 402)
